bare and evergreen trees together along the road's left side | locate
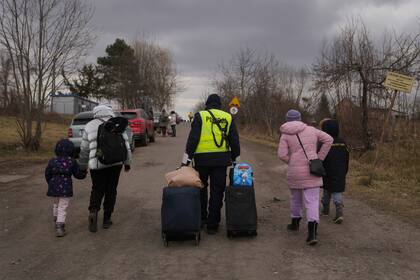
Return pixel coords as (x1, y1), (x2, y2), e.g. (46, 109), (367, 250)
(0, 0), (180, 150)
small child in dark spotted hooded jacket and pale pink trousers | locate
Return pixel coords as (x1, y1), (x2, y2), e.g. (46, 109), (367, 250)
(45, 139), (86, 237)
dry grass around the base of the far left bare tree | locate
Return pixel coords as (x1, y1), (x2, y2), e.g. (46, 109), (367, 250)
(0, 116), (69, 162)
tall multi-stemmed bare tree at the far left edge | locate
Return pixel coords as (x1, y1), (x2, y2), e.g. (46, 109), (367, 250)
(0, 0), (93, 150)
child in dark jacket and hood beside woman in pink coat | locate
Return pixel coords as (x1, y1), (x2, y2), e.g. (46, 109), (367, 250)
(321, 119), (349, 224)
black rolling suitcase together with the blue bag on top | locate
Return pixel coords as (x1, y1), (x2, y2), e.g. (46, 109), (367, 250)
(225, 163), (257, 238)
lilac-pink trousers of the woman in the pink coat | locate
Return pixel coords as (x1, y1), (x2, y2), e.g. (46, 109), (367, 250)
(290, 188), (319, 222)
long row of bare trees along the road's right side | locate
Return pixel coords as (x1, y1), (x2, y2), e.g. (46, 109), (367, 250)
(212, 18), (420, 151)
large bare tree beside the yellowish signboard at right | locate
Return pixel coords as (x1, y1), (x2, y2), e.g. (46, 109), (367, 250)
(313, 19), (420, 150)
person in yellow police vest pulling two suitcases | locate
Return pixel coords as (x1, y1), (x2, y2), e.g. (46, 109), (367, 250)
(182, 94), (240, 234)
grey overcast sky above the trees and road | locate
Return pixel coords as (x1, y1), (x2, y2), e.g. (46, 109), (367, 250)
(89, 0), (420, 114)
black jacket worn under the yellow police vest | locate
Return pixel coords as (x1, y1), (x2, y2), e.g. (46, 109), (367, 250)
(186, 106), (241, 166)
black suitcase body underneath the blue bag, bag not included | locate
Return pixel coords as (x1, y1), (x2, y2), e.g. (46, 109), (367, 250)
(225, 172), (257, 238)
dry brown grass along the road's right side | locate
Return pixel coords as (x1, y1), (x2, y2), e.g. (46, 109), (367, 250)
(241, 130), (420, 225)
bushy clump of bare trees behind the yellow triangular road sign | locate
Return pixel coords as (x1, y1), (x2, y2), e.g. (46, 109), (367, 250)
(213, 49), (308, 136)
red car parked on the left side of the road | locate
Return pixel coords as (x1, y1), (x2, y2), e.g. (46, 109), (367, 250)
(120, 109), (155, 146)
